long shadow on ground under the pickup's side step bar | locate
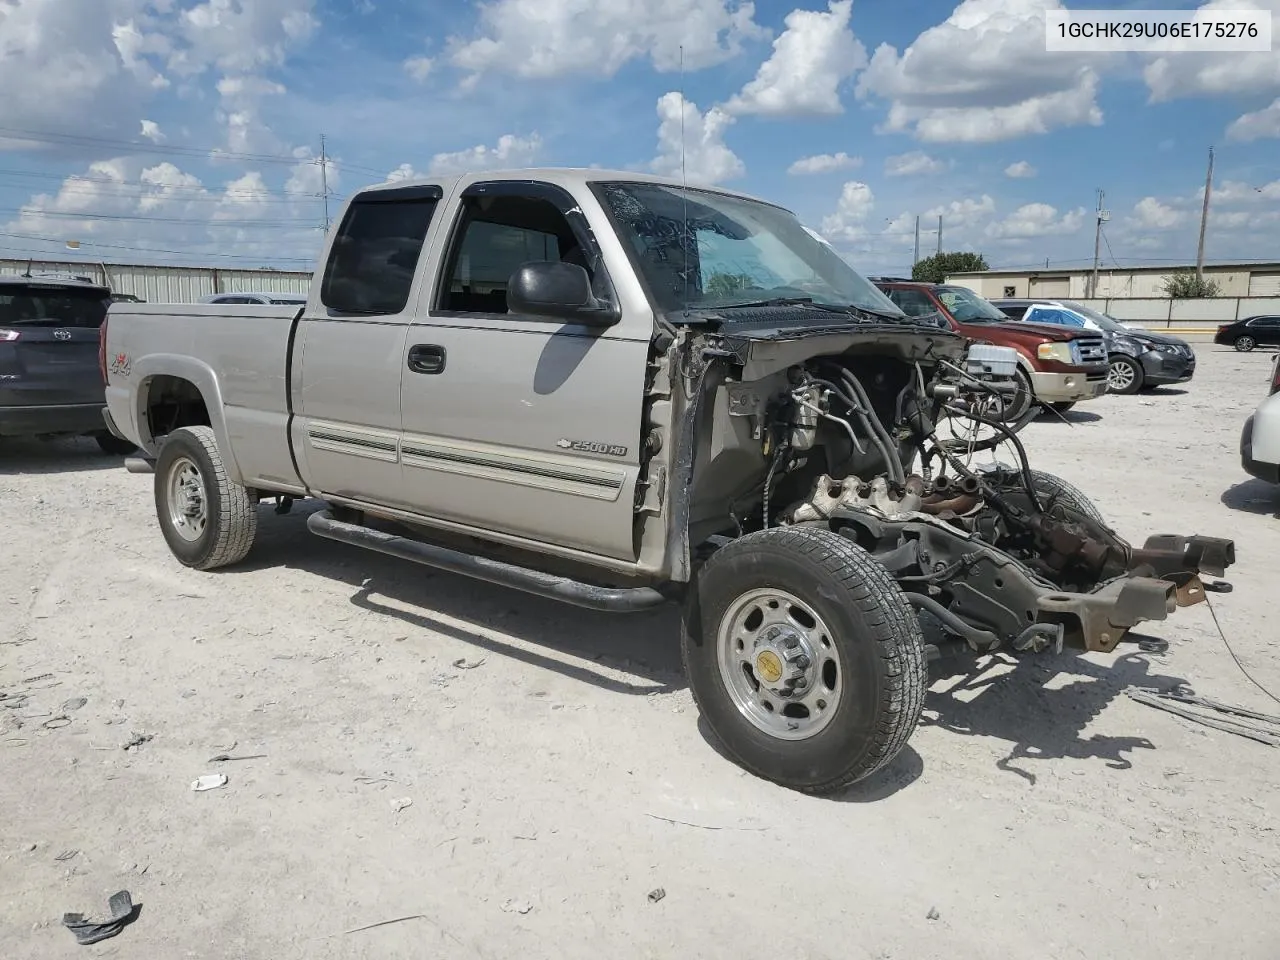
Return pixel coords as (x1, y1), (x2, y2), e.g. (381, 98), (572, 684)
(225, 503), (686, 696)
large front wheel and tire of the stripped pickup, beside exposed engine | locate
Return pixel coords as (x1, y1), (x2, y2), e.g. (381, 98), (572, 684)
(681, 527), (927, 795)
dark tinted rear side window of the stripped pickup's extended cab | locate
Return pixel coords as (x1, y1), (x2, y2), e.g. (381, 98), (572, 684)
(320, 187), (440, 316)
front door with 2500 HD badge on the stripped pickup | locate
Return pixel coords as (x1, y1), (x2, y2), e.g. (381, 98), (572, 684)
(401, 180), (653, 559)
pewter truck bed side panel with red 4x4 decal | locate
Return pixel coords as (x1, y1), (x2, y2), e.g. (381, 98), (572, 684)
(105, 303), (302, 489)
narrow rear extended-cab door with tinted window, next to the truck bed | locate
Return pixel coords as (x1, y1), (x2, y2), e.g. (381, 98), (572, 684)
(291, 184), (443, 506)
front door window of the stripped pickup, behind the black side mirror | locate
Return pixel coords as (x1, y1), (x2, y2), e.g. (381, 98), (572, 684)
(438, 193), (590, 314)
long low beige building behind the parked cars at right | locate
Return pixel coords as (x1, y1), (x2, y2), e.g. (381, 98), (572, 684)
(947, 262), (1280, 300)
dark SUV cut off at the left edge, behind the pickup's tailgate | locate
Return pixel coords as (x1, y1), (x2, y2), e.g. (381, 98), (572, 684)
(0, 275), (134, 454)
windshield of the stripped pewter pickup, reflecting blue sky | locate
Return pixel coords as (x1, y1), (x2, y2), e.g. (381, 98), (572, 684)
(595, 183), (906, 320)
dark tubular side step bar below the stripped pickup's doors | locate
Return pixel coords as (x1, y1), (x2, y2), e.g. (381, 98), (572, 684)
(307, 509), (669, 613)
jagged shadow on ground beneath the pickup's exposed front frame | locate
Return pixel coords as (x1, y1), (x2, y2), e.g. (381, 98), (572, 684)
(922, 644), (1185, 785)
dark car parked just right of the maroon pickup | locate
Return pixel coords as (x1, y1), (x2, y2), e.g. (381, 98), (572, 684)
(991, 300), (1196, 393)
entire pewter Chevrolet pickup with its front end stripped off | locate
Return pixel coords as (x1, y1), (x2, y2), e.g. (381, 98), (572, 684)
(94, 169), (1234, 794)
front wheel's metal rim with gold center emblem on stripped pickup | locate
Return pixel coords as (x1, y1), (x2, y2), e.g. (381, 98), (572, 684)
(716, 588), (844, 740)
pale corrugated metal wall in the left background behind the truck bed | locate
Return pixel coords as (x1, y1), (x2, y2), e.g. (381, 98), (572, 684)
(0, 259), (311, 303)
